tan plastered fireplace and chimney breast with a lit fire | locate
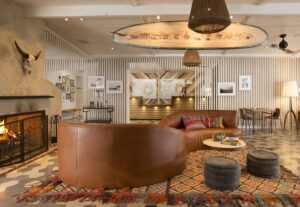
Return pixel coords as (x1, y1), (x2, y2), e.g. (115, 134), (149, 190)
(0, 0), (61, 162)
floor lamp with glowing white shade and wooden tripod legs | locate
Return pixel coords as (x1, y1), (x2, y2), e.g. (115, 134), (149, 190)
(282, 81), (298, 131)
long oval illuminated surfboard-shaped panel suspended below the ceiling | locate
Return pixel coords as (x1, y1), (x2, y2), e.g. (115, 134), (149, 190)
(113, 21), (269, 50)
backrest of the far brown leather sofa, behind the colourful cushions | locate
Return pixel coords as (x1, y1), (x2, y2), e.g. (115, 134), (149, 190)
(159, 110), (238, 128)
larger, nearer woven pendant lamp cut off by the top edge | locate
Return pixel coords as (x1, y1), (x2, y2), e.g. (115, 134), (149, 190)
(188, 0), (231, 34)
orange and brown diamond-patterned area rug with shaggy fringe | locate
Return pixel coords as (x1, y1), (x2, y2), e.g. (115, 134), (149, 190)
(17, 150), (300, 206)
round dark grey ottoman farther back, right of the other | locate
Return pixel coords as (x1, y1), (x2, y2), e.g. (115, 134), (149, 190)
(247, 150), (280, 178)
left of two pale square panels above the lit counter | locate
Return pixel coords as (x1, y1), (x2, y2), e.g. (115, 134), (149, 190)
(132, 79), (157, 99)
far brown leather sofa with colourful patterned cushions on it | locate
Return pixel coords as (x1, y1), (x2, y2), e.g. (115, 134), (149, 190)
(159, 110), (242, 152)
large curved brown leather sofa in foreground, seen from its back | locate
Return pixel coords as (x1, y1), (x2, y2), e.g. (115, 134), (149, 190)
(58, 122), (187, 188)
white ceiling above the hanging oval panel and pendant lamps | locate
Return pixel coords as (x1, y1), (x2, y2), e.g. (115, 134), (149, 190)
(14, 0), (300, 56)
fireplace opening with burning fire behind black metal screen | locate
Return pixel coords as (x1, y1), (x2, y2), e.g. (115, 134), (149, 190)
(0, 111), (48, 167)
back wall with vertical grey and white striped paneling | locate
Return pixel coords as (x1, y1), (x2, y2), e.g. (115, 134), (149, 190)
(46, 56), (300, 126)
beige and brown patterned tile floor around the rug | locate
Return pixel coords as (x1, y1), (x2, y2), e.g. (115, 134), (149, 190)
(0, 130), (300, 207)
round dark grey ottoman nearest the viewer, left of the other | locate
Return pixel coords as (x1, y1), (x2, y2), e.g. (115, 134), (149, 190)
(204, 157), (241, 191)
